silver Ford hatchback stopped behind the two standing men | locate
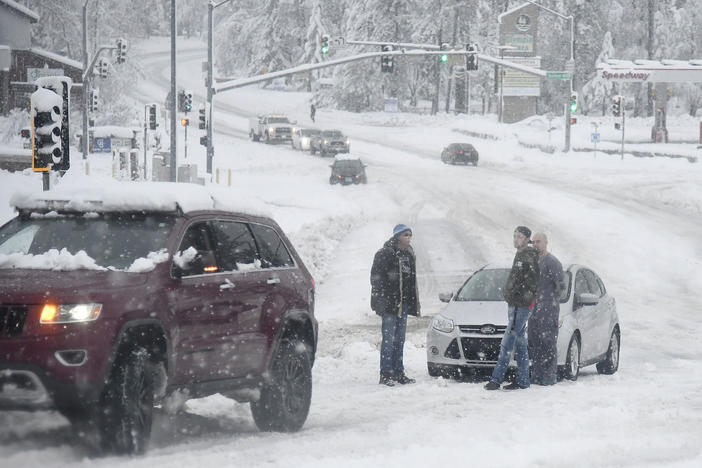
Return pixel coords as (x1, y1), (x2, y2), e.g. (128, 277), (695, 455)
(427, 265), (621, 380)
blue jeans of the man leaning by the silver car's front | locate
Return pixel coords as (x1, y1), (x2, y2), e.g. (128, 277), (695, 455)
(491, 306), (531, 387)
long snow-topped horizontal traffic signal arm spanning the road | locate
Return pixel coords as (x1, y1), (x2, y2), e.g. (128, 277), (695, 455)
(213, 49), (546, 93)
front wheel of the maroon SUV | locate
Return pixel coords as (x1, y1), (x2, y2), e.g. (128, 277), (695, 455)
(100, 348), (155, 455)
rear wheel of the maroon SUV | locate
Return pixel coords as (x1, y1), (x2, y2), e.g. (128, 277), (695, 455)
(251, 340), (312, 432)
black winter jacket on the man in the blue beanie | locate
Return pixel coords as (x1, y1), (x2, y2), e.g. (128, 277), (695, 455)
(370, 237), (420, 317)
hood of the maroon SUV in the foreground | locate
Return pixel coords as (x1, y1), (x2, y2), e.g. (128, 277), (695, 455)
(0, 269), (149, 302)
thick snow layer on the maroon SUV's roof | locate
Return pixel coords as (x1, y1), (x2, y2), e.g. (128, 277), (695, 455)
(10, 177), (271, 217)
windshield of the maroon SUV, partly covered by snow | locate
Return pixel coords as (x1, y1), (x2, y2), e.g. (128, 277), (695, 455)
(0, 213), (175, 269)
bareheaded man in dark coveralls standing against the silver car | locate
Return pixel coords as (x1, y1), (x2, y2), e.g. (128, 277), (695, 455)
(528, 232), (563, 385)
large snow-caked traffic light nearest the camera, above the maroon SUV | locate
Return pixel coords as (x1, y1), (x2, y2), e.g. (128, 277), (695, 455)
(31, 87), (63, 171)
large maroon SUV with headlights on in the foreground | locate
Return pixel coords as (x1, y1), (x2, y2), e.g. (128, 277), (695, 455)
(0, 184), (317, 454)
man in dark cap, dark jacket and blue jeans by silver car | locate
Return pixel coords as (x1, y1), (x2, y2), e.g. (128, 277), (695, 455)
(485, 226), (539, 390)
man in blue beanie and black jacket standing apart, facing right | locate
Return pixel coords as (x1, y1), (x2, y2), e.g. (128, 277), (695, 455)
(371, 224), (419, 387)
